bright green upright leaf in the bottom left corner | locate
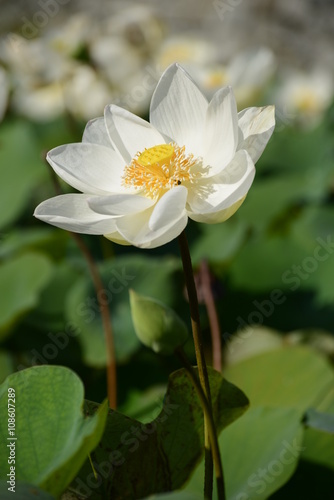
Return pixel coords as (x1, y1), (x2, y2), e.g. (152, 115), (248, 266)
(0, 366), (107, 496)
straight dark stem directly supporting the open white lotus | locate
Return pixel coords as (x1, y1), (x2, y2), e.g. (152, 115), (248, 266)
(178, 231), (213, 499)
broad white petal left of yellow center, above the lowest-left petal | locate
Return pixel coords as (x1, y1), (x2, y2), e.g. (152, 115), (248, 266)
(47, 143), (125, 194)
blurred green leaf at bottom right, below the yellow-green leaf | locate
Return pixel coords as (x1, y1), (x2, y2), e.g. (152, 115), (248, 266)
(185, 406), (303, 500)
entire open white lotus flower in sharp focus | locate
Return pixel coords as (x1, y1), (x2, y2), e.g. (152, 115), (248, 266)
(34, 64), (274, 248)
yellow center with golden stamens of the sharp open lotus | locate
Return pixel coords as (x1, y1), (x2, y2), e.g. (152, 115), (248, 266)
(123, 143), (202, 198)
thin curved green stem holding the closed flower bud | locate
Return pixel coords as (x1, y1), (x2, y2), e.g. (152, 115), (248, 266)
(175, 347), (226, 500)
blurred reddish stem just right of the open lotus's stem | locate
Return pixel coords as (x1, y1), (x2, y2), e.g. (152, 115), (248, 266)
(200, 260), (222, 372)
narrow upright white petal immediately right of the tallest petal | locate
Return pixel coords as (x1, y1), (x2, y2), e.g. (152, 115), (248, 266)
(203, 87), (238, 175)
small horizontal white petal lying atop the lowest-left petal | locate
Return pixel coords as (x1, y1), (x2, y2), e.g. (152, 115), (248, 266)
(88, 194), (155, 216)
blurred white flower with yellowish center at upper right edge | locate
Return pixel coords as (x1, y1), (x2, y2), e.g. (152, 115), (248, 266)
(272, 68), (334, 127)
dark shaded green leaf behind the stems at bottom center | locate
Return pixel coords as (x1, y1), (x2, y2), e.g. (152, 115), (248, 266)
(72, 369), (248, 500)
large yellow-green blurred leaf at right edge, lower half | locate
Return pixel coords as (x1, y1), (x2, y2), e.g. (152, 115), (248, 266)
(225, 342), (334, 474)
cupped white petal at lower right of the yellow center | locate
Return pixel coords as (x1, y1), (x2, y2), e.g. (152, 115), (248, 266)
(188, 147), (255, 222)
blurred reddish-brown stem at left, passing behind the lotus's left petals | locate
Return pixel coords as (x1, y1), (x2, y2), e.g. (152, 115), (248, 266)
(47, 163), (117, 410)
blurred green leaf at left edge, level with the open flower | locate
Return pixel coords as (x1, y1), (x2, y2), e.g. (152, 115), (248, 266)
(0, 121), (48, 229)
